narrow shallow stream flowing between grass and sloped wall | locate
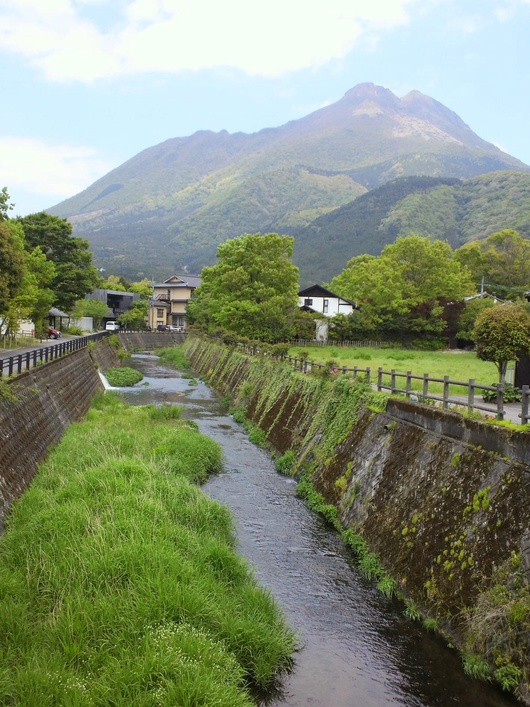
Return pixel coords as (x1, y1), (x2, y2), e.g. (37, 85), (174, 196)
(116, 354), (519, 707)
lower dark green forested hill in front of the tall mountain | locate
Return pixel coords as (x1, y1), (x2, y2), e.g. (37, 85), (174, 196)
(292, 171), (530, 286)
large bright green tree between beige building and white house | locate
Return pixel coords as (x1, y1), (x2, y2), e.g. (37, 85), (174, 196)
(188, 233), (298, 341)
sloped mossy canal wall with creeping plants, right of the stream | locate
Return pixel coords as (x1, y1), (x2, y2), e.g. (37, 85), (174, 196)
(186, 338), (530, 704)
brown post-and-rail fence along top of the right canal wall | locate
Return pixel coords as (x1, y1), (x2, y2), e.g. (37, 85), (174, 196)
(284, 356), (530, 425)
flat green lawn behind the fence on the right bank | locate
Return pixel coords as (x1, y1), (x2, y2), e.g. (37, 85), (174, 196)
(289, 346), (498, 395)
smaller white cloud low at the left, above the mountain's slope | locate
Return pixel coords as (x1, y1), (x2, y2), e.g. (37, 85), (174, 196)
(0, 136), (115, 213)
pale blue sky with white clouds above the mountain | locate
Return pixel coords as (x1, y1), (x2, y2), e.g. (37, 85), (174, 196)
(0, 0), (530, 215)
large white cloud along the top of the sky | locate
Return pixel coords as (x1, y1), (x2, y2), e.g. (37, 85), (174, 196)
(0, 0), (419, 82)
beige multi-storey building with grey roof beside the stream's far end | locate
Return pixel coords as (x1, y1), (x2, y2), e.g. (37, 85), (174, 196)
(149, 275), (201, 331)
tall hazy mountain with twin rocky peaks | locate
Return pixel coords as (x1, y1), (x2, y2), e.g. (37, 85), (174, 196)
(48, 84), (530, 278)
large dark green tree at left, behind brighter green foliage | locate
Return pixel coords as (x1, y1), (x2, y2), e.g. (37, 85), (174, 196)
(15, 211), (100, 312)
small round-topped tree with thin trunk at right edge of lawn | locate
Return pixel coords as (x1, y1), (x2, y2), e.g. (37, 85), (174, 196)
(473, 304), (530, 385)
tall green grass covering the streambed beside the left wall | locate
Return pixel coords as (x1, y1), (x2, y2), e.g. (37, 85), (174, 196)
(0, 394), (295, 707)
